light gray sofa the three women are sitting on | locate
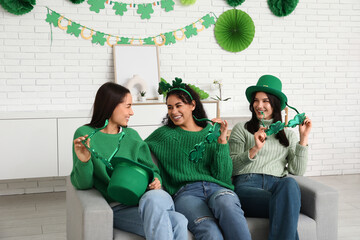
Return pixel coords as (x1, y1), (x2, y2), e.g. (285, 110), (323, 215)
(66, 176), (338, 240)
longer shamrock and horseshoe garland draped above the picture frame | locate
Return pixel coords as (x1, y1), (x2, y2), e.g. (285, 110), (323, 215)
(45, 8), (215, 47)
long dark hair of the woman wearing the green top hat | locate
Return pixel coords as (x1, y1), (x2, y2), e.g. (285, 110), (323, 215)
(245, 92), (289, 147)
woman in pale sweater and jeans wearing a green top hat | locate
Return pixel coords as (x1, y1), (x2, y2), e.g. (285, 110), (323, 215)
(229, 75), (312, 240)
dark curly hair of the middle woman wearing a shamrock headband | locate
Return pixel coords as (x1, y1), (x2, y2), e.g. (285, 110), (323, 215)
(162, 84), (207, 128)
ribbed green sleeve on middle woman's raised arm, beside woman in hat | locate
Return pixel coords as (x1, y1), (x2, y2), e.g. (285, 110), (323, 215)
(211, 143), (233, 187)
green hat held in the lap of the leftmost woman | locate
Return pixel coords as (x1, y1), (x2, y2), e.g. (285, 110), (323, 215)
(107, 157), (154, 206)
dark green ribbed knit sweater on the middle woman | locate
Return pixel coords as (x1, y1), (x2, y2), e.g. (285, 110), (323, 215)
(145, 124), (234, 195)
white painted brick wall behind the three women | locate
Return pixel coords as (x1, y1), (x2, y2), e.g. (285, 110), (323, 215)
(0, 0), (360, 175)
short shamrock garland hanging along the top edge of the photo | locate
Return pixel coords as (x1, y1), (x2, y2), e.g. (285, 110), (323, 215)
(87, 0), (175, 19)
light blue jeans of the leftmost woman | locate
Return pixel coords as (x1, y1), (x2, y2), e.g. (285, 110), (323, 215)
(113, 190), (188, 240)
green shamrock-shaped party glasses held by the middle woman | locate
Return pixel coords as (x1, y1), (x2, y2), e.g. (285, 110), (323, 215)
(189, 116), (221, 163)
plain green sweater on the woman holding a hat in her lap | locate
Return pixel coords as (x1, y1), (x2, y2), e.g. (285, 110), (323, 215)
(70, 126), (161, 203)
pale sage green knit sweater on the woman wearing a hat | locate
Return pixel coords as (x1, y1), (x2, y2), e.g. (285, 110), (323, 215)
(229, 120), (308, 177)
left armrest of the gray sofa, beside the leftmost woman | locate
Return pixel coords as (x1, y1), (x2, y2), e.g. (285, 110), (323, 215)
(66, 177), (113, 240)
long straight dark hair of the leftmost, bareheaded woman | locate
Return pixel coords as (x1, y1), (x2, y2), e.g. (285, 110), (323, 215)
(86, 82), (130, 128)
